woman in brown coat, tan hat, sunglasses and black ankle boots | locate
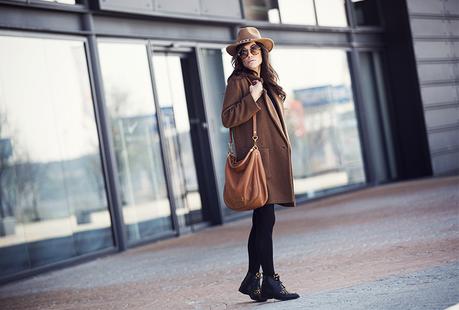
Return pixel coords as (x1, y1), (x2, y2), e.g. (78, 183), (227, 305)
(222, 27), (299, 301)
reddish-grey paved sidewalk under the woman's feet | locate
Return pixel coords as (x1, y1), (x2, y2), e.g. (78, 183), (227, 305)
(0, 177), (459, 310)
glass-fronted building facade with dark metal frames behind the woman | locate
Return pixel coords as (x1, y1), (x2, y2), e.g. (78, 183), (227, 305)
(0, 0), (459, 283)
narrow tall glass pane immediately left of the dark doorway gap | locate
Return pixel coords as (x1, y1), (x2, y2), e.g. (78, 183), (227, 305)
(153, 55), (202, 226)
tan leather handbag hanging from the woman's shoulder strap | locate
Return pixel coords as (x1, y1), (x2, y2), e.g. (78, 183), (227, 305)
(223, 113), (268, 211)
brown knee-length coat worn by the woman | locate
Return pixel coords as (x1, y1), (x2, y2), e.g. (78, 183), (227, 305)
(222, 74), (296, 207)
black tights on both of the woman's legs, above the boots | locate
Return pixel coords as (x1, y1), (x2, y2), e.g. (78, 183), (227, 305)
(248, 204), (276, 275)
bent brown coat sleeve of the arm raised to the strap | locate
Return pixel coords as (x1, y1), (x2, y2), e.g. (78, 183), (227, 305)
(222, 80), (261, 128)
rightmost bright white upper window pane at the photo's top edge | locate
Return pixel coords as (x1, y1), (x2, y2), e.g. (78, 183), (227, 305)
(315, 0), (347, 27)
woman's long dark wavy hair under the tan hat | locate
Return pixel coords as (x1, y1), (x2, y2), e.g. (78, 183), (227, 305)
(228, 42), (286, 101)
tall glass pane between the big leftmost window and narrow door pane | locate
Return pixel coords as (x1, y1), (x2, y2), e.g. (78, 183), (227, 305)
(98, 42), (173, 242)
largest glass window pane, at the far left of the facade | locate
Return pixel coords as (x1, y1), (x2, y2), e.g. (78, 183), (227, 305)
(0, 36), (113, 276)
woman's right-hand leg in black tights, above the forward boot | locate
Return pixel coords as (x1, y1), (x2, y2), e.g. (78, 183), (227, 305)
(253, 204), (276, 275)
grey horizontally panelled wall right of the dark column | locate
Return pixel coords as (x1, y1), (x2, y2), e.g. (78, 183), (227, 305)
(408, 0), (459, 174)
